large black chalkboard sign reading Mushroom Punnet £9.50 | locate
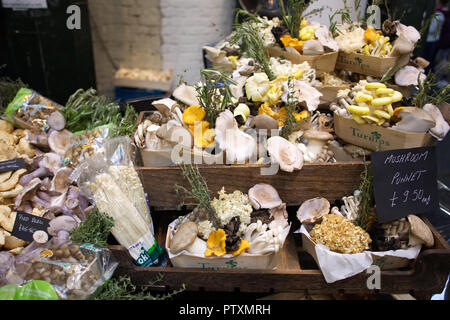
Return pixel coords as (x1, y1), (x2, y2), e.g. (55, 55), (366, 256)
(371, 147), (439, 223)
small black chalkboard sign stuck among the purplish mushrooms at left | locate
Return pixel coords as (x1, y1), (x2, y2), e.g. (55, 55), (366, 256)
(11, 211), (50, 242)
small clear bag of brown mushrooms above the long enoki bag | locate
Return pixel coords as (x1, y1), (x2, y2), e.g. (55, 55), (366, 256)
(64, 125), (111, 168)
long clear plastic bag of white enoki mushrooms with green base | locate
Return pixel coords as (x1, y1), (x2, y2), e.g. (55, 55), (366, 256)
(74, 137), (167, 267)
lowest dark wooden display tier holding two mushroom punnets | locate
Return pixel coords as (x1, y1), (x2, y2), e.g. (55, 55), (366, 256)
(110, 211), (450, 299)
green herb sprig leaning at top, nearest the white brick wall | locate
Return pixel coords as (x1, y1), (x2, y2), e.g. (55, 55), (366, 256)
(230, 22), (276, 80)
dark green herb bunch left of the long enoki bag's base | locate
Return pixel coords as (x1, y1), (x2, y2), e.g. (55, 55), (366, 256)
(70, 209), (114, 247)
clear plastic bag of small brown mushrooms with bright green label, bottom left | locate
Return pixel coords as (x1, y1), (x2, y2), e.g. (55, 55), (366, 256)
(0, 238), (118, 300)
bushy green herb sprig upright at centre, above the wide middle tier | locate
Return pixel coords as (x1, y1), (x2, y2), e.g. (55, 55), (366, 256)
(195, 68), (236, 128)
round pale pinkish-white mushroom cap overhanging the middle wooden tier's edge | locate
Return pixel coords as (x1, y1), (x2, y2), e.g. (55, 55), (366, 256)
(267, 136), (303, 172)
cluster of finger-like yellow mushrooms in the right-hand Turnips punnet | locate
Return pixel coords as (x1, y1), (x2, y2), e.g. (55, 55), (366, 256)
(347, 82), (403, 126)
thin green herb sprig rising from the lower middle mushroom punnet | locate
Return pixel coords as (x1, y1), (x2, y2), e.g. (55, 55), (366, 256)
(175, 163), (221, 228)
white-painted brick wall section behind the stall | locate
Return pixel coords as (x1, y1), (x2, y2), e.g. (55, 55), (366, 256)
(160, 0), (235, 87)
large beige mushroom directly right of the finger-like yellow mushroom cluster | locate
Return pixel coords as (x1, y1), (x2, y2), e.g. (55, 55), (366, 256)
(392, 107), (436, 132)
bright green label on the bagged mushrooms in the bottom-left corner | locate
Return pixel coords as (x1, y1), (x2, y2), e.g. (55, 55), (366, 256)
(0, 280), (58, 300)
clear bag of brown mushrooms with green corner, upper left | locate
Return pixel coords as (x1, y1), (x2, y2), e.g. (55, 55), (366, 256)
(5, 88), (63, 132)
